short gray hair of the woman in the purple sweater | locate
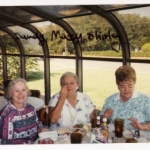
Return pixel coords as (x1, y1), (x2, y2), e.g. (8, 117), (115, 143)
(5, 78), (31, 100)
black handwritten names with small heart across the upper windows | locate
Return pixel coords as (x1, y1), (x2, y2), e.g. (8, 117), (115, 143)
(15, 30), (120, 52)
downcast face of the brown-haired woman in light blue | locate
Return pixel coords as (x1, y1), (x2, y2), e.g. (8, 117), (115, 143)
(118, 80), (135, 101)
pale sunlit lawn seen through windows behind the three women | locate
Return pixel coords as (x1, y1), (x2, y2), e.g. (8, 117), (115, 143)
(28, 69), (150, 109)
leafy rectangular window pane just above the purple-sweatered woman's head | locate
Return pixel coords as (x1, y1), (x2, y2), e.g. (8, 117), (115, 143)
(7, 56), (21, 79)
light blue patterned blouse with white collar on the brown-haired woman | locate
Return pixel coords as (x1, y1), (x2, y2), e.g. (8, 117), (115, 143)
(100, 91), (150, 129)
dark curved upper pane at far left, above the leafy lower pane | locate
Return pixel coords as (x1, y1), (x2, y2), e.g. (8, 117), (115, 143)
(0, 31), (20, 54)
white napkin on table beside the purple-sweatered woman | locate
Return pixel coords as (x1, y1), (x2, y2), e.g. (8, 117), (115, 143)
(39, 131), (58, 141)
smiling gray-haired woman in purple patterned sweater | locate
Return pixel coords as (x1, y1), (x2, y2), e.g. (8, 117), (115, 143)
(0, 78), (46, 144)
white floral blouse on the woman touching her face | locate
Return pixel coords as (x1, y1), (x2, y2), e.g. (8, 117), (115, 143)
(48, 92), (95, 130)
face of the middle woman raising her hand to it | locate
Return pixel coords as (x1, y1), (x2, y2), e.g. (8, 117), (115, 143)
(63, 76), (78, 92)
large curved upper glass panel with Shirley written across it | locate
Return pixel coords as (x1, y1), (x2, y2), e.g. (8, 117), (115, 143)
(66, 15), (122, 57)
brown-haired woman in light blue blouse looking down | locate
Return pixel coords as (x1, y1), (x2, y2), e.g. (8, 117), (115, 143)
(100, 66), (150, 130)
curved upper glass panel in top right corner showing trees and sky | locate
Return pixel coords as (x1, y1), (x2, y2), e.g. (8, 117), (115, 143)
(114, 7), (150, 59)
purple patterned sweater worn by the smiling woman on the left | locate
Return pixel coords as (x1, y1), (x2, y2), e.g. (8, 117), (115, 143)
(0, 102), (43, 144)
